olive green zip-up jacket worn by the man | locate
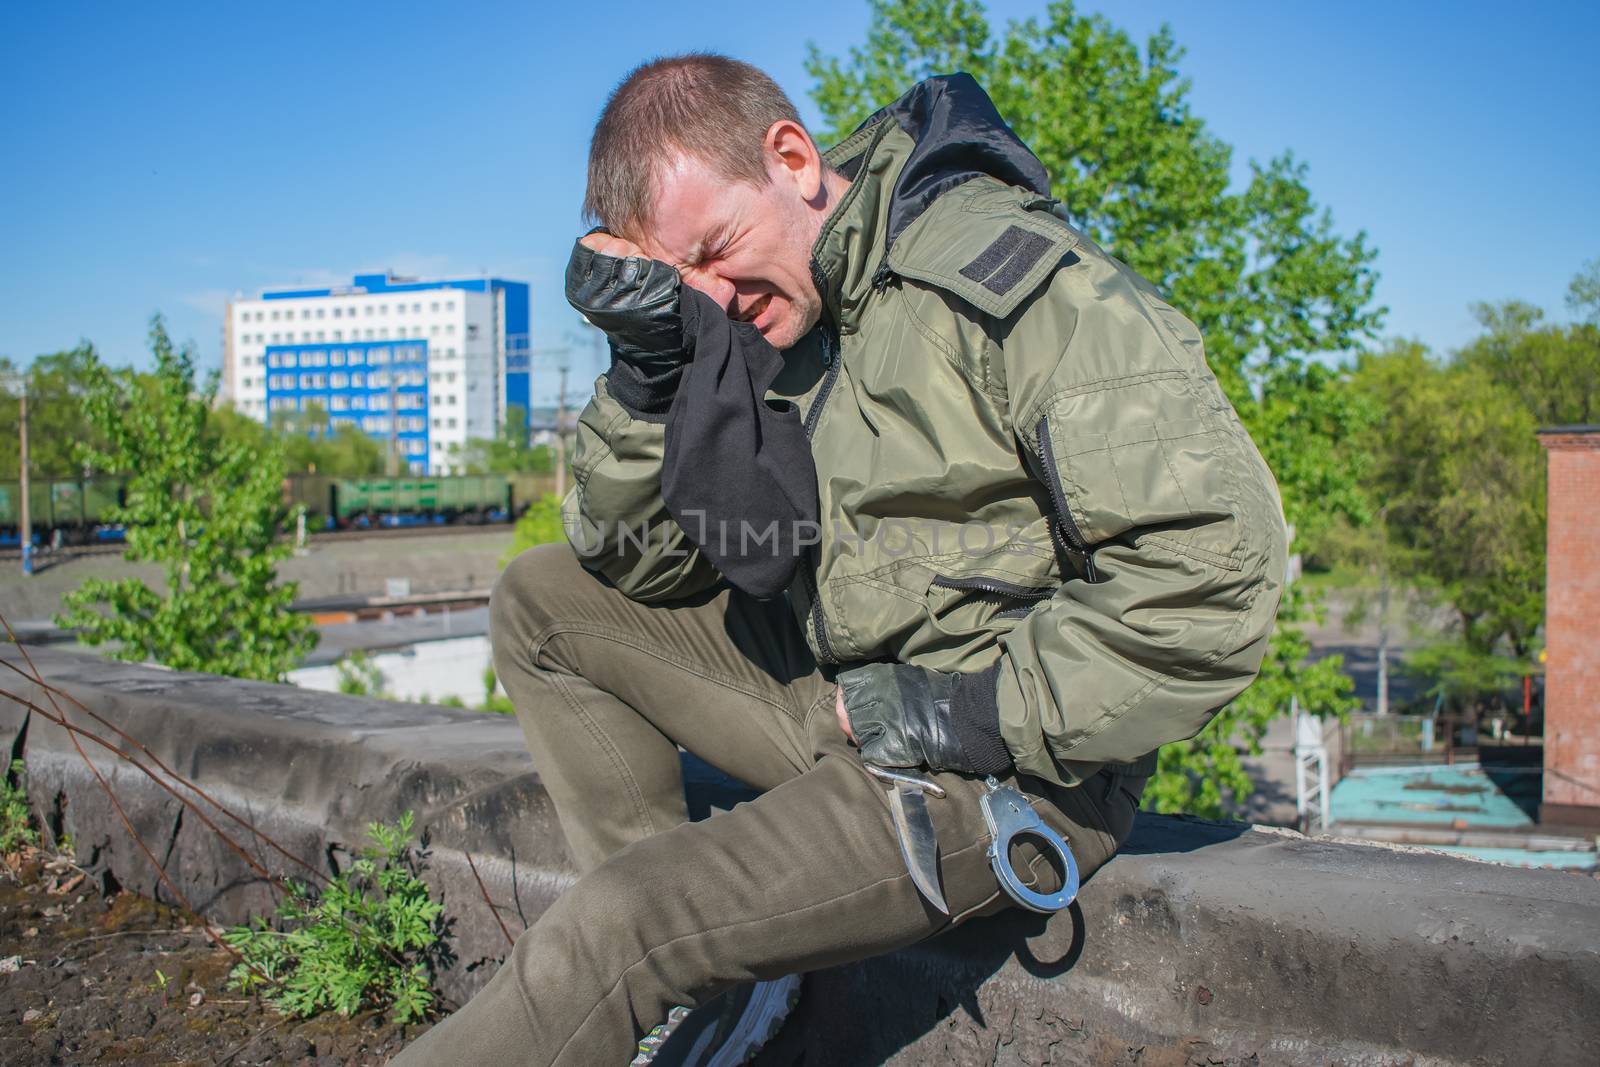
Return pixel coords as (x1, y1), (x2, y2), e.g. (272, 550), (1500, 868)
(563, 81), (1286, 784)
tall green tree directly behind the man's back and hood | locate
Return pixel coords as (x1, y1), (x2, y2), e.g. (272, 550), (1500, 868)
(806, 0), (1382, 814)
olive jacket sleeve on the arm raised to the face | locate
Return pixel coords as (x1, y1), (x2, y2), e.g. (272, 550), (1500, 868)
(562, 376), (718, 603)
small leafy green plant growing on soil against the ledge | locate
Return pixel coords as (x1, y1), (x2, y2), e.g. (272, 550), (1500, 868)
(222, 811), (443, 1022)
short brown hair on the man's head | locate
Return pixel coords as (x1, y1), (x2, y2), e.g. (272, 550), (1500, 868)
(584, 53), (800, 237)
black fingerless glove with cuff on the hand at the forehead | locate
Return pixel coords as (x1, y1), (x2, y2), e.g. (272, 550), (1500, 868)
(566, 233), (690, 421)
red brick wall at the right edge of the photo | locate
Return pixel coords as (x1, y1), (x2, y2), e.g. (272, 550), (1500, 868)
(1539, 426), (1600, 825)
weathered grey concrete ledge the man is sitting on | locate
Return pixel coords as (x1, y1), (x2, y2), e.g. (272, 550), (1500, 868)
(0, 646), (1600, 1065)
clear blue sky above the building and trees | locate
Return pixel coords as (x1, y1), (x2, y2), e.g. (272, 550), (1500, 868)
(0, 0), (1600, 395)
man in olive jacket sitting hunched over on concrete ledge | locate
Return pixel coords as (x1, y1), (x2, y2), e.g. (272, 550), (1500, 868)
(398, 56), (1285, 1064)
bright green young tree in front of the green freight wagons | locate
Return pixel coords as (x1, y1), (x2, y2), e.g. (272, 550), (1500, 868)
(56, 315), (317, 680)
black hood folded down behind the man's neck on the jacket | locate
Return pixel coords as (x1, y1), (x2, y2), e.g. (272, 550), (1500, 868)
(840, 72), (1050, 250)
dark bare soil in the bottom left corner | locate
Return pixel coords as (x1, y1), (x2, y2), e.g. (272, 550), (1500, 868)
(0, 853), (427, 1067)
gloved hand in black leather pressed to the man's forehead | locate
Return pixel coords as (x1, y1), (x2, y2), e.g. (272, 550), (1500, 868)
(566, 231), (688, 378)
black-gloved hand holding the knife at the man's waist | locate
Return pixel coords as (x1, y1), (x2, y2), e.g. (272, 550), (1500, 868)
(838, 664), (1011, 774)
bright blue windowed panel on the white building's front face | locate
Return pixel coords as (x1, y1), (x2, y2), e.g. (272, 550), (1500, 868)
(266, 338), (430, 472)
